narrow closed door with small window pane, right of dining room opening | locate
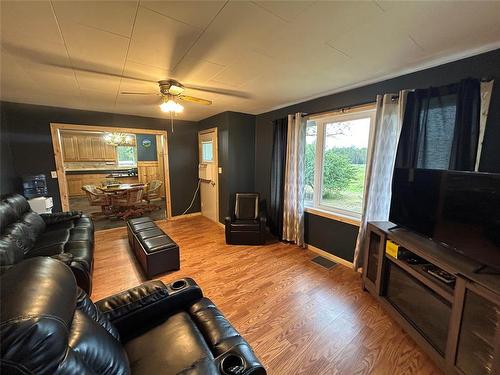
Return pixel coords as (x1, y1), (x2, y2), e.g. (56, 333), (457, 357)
(198, 128), (219, 222)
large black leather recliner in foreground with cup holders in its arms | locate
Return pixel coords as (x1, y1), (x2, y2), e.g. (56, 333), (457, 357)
(0, 257), (266, 375)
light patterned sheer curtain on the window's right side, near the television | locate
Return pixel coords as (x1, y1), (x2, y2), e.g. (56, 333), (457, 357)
(354, 91), (408, 269)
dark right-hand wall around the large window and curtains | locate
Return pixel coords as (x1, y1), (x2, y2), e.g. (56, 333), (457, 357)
(255, 50), (500, 260)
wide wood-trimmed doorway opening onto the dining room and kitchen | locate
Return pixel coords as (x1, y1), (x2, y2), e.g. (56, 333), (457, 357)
(51, 124), (171, 230)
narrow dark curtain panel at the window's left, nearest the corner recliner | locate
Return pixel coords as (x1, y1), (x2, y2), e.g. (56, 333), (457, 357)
(269, 118), (288, 239)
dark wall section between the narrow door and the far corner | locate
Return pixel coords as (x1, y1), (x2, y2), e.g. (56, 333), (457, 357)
(199, 112), (255, 223)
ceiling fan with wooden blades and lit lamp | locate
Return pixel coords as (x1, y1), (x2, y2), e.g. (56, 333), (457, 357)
(120, 79), (212, 114)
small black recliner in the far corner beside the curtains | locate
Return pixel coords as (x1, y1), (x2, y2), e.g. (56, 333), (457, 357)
(225, 193), (267, 245)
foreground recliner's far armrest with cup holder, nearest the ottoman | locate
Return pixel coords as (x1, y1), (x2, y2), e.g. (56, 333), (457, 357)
(96, 278), (203, 341)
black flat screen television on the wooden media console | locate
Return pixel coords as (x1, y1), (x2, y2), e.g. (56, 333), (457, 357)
(389, 168), (500, 271)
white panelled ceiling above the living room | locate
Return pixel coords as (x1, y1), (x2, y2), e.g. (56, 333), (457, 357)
(1, 0), (500, 120)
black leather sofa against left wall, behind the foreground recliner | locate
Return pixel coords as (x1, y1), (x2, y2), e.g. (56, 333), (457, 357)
(0, 194), (94, 294)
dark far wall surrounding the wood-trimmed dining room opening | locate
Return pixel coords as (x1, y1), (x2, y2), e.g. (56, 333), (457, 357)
(1, 102), (200, 215)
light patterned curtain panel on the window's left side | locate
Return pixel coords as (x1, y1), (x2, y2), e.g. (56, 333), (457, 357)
(283, 113), (306, 246)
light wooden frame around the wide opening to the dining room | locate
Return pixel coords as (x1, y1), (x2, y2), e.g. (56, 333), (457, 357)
(50, 122), (172, 219)
